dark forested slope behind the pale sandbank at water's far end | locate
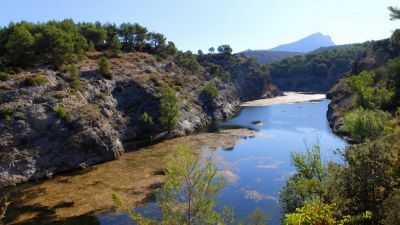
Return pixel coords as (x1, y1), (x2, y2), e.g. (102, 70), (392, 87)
(268, 43), (369, 92)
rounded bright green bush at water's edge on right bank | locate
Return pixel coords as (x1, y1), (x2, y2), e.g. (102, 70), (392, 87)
(342, 108), (391, 142)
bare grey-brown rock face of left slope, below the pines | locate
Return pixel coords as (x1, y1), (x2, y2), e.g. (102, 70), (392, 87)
(0, 53), (275, 187)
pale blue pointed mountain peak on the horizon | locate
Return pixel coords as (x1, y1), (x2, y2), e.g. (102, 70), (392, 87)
(269, 33), (335, 53)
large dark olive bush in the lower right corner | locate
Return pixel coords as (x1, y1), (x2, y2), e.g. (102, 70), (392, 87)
(335, 130), (400, 224)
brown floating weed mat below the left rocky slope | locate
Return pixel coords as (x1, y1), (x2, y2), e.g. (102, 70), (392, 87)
(1, 129), (258, 225)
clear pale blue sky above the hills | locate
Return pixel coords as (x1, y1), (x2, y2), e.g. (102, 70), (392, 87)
(0, 0), (400, 52)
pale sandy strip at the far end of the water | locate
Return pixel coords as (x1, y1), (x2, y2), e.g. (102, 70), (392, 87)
(240, 92), (326, 106)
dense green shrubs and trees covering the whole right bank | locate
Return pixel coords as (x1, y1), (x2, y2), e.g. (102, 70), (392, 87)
(281, 8), (400, 225)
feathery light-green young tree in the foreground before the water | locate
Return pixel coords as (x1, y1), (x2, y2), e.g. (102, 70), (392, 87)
(113, 146), (224, 225)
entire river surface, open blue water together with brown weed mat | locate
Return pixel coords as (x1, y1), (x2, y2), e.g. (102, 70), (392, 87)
(3, 100), (345, 224)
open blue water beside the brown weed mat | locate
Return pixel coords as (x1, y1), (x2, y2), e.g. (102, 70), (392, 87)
(96, 100), (346, 225)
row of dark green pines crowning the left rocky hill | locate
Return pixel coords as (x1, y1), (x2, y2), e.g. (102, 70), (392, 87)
(0, 19), (177, 69)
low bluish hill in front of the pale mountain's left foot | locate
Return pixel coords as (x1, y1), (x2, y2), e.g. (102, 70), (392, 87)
(242, 50), (303, 64)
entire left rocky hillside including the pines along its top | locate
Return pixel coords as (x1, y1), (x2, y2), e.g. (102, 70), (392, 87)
(0, 21), (277, 187)
